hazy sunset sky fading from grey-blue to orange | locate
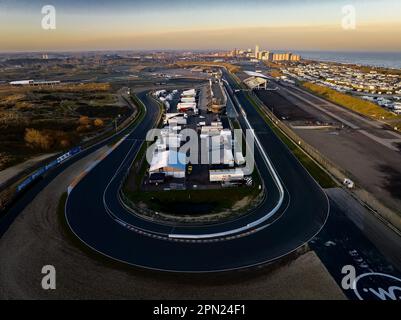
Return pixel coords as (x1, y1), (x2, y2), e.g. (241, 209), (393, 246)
(0, 0), (401, 51)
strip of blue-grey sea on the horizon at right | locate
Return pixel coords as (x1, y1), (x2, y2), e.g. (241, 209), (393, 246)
(297, 51), (401, 69)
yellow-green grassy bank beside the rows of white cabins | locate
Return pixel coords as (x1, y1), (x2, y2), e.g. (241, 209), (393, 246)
(301, 82), (401, 127)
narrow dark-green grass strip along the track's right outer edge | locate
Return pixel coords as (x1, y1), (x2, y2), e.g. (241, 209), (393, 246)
(247, 92), (336, 188)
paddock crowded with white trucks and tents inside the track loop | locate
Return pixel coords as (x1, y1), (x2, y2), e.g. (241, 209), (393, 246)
(142, 84), (252, 191)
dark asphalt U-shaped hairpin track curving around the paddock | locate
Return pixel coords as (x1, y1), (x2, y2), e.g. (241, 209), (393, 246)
(66, 81), (329, 272)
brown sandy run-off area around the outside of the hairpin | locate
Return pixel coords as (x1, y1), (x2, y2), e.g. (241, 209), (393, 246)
(0, 140), (345, 299)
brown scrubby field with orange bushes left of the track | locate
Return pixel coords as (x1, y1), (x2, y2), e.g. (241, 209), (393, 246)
(0, 83), (130, 170)
